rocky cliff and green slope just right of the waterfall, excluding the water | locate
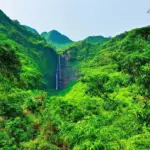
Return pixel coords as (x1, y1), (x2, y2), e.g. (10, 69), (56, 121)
(58, 36), (110, 88)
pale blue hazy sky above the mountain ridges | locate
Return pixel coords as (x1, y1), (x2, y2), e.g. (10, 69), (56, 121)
(0, 0), (150, 40)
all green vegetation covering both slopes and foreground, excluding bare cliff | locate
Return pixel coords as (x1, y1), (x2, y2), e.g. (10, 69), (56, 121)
(0, 9), (150, 150)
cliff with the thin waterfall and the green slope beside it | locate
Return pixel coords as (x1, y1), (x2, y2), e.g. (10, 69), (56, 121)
(56, 41), (106, 89)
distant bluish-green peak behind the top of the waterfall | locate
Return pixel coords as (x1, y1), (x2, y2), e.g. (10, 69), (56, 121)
(41, 30), (73, 49)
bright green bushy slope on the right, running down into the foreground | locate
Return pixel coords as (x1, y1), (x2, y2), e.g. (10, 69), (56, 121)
(46, 26), (150, 150)
